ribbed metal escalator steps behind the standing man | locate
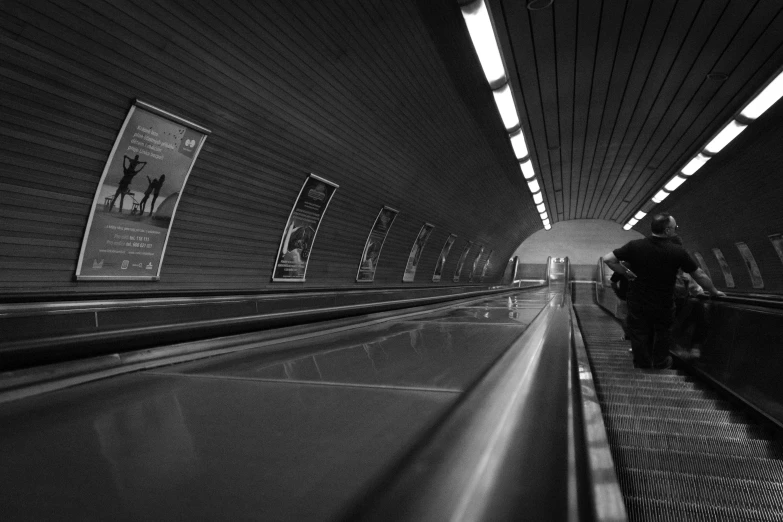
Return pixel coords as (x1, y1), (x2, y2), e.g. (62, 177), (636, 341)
(574, 301), (783, 521)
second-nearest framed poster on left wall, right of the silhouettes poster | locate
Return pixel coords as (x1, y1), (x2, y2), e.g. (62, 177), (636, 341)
(272, 174), (339, 282)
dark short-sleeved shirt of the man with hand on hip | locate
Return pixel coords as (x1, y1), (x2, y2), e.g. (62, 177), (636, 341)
(613, 236), (699, 308)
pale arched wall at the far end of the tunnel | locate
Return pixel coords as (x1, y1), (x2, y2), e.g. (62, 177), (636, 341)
(513, 219), (644, 281)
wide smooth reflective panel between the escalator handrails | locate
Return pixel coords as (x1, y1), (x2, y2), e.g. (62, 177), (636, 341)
(0, 289), (549, 521)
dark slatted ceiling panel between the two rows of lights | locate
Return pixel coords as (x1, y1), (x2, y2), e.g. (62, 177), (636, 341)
(435, 0), (783, 223)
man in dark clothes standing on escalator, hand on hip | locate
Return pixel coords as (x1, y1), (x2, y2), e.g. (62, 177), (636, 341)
(603, 214), (725, 369)
